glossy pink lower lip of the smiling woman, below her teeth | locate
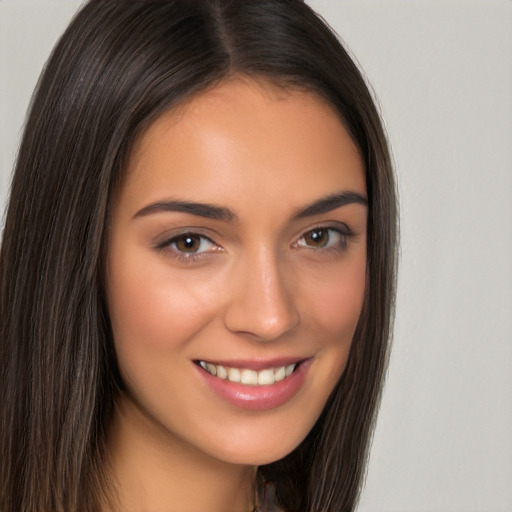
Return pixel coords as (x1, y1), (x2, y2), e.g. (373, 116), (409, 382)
(197, 360), (311, 411)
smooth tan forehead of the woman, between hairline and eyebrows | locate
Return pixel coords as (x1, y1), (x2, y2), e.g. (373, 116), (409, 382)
(122, 79), (365, 217)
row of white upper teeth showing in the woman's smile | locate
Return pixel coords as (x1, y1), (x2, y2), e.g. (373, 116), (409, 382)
(196, 361), (300, 386)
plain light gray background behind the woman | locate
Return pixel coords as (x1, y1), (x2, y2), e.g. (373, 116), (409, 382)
(0, 0), (512, 512)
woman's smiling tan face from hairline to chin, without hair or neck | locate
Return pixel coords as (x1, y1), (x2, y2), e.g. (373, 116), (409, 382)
(107, 79), (367, 465)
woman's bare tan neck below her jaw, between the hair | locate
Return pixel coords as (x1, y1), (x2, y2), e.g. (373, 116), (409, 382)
(105, 399), (257, 512)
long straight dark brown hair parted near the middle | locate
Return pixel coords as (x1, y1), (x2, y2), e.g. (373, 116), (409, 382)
(0, 0), (396, 512)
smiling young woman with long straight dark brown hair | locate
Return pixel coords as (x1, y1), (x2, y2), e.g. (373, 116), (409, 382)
(0, 0), (396, 512)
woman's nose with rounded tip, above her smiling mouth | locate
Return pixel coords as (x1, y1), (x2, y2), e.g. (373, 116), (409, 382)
(224, 247), (300, 341)
